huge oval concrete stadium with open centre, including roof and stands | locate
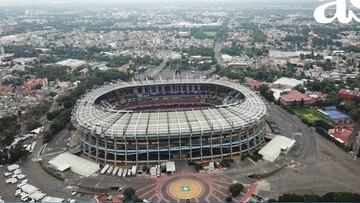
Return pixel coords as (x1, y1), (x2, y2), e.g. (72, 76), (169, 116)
(72, 78), (267, 164)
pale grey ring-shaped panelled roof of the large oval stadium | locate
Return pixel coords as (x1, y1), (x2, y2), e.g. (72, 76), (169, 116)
(73, 78), (266, 138)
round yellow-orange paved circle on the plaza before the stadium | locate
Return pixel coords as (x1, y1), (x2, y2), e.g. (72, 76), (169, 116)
(169, 179), (204, 199)
